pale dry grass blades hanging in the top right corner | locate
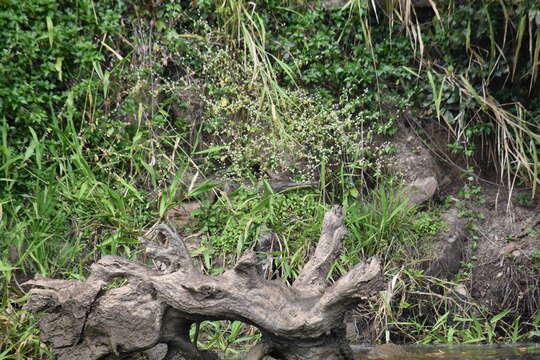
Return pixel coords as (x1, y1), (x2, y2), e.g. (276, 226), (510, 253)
(358, 0), (540, 196)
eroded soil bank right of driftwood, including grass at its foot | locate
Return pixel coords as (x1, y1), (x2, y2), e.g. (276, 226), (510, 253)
(349, 126), (540, 342)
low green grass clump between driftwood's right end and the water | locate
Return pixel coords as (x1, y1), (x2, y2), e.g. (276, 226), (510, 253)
(379, 270), (537, 344)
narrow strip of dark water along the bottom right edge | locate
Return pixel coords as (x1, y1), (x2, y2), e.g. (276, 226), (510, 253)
(353, 344), (540, 360)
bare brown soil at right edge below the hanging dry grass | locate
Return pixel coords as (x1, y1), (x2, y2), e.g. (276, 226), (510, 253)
(466, 185), (540, 318)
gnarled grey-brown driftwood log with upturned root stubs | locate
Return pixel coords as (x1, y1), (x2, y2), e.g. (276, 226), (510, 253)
(25, 207), (383, 360)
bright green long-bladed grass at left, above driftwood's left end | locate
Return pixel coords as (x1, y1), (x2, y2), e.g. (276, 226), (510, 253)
(0, 97), (196, 358)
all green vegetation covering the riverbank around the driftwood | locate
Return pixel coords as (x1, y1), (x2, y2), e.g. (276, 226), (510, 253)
(0, 0), (540, 359)
